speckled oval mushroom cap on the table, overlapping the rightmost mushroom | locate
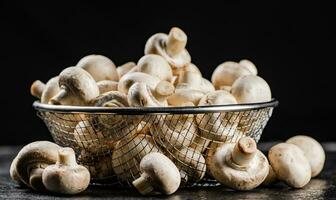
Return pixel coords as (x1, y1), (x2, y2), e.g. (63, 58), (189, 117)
(268, 143), (311, 188)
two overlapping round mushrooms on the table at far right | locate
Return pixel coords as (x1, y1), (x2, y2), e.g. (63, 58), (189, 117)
(264, 135), (325, 188)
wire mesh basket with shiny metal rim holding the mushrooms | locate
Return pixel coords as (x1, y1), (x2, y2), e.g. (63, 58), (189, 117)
(33, 100), (278, 186)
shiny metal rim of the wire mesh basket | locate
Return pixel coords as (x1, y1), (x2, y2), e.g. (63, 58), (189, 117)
(33, 99), (279, 115)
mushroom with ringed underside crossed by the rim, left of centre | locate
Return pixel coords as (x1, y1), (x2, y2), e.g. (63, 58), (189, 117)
(90, 91), (141, 140)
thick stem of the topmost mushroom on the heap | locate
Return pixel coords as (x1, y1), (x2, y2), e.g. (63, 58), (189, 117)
(166, 27), (187, 56)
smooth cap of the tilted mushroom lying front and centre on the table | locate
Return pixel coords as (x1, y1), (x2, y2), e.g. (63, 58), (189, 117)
(140, 152), (181, 194)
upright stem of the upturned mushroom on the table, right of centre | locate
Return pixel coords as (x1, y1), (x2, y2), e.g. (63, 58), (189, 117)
(231, 137), (257, 166)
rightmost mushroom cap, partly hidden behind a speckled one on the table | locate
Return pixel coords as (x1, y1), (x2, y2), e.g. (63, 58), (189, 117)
(286, 135), (325, 177)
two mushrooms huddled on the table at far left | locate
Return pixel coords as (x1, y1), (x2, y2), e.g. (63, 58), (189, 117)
(10, 141), (90, 194)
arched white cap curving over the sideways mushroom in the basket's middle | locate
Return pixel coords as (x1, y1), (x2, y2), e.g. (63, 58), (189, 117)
(118, 72), (160, 94)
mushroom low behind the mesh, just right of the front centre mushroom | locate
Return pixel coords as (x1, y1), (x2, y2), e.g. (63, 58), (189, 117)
(167, 147), (206, 184)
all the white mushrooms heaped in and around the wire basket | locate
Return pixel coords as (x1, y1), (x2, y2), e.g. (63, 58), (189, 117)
(10, 27), (324, 194)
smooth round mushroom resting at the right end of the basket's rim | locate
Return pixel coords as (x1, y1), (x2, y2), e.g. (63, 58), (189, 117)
(231, 75), (272, 104)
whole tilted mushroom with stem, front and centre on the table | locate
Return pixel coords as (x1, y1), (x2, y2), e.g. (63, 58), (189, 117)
(132, 152), (181, 195)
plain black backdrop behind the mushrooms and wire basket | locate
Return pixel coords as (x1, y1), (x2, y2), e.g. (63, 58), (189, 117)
(0, 1), (336, 144)
